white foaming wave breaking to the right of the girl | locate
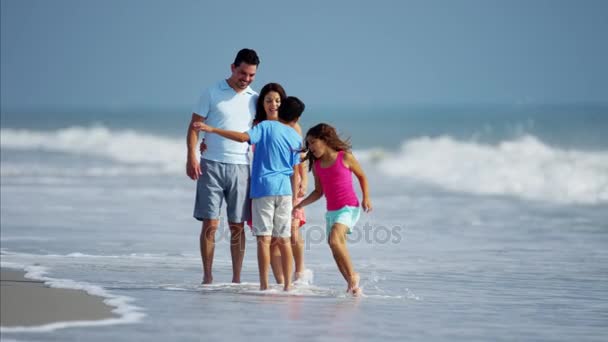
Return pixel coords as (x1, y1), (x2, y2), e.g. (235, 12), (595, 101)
(376, 135), (608, 204)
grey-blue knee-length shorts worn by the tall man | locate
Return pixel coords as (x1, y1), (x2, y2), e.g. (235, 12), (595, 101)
(193, 159), (251, 223)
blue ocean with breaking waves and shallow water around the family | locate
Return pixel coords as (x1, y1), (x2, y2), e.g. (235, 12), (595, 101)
(0, 104), (608, 342)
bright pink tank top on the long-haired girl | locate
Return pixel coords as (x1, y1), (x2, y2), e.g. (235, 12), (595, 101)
(314, 151), (359, 211)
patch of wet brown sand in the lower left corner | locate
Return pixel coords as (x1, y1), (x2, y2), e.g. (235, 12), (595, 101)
(0, 267), (120, 331)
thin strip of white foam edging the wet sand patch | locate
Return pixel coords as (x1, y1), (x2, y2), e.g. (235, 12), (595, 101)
(0, 261), (145, 333)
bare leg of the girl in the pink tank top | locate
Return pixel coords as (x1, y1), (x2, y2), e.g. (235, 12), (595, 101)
(329, 223), (360, 295)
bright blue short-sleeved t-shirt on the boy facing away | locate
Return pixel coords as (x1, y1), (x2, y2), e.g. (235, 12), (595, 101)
(247, 120), (302, 198)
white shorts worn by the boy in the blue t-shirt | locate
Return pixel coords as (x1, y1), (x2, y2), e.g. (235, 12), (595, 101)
(251, 196), (293, 238)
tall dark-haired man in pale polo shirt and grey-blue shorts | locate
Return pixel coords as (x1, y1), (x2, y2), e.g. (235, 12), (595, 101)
(186, 49), (260, 284)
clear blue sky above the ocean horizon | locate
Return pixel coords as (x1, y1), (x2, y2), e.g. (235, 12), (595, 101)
(0, 0), (608, 111)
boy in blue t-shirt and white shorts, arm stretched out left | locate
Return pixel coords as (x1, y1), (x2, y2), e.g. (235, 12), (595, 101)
(193, 96), (305, 291)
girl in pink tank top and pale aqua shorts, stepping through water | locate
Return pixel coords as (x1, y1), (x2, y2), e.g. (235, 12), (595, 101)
(293, 123), (372, 296)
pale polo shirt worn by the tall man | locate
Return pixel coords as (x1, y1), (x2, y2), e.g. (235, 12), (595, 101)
(193, 80), (258, 164)
